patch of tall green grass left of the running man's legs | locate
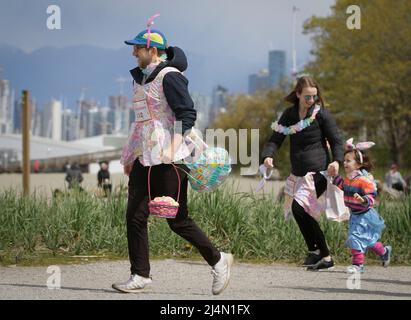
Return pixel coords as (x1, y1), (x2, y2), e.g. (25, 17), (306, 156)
(0, 190), (127, 254)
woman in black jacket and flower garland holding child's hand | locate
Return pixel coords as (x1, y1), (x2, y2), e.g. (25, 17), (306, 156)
(262, 76), (343, 270)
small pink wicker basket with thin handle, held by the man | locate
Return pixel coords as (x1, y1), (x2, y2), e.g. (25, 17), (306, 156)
(148, 164), (180, 219)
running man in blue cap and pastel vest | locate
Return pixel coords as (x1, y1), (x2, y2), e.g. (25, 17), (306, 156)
(112, 19), (233, 294)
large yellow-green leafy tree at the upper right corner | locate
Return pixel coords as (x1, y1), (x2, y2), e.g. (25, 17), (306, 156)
(304, 0), (411, 162)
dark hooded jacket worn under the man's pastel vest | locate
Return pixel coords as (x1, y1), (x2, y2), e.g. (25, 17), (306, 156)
(130, 47), (197, 134)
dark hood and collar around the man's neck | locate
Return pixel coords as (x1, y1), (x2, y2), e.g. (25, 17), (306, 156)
(130, 47), (188, 83)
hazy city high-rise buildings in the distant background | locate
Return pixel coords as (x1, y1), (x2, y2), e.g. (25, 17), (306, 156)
(0, 42), (296, 141)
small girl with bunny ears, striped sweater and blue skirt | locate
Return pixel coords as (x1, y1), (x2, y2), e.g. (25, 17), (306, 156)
(334, 139), (392, 273)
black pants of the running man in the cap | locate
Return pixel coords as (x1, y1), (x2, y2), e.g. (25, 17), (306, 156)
(127, 159), (221, 278)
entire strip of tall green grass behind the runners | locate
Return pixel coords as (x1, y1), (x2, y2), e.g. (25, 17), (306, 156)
(0, 185), (411, 264)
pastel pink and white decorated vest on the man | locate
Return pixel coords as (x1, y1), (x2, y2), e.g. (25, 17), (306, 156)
(120, 67), (190, 166)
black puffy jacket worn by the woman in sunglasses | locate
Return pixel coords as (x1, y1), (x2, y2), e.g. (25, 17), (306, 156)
(261, 105), (344, 177)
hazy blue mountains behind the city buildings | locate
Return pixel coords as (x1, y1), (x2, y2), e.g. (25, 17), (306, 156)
(0, 45), (265, 108)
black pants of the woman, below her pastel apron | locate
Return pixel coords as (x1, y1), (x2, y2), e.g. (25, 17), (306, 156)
(291, 172), (330, 257)
